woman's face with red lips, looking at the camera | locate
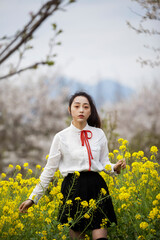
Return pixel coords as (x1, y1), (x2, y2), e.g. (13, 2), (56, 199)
(69, 96), (91, 123)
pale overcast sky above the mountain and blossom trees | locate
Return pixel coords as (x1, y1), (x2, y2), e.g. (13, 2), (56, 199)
(0, 0), (160, 88)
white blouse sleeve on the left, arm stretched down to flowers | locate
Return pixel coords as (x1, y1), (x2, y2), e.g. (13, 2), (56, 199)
(29, 134), (61, 204)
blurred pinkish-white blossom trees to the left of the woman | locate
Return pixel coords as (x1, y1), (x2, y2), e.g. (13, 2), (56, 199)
(0, 76), (67, 172)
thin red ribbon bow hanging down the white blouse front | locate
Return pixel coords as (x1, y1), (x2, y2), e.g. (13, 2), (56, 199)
(81, 130), (93, 171)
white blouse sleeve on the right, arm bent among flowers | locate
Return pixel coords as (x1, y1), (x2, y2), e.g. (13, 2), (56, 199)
(100, 132), (117, 175)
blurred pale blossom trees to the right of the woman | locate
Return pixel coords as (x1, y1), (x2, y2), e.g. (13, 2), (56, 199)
(103, 81), (160, 161)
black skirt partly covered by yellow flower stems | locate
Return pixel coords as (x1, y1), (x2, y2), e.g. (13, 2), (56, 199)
(58, 171), (117, 232)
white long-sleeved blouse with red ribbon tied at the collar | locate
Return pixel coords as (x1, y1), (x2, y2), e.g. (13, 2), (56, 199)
(29, 123), (116, 204)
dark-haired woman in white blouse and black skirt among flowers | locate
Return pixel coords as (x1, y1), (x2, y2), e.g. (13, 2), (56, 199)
(19, 92), (126, 240)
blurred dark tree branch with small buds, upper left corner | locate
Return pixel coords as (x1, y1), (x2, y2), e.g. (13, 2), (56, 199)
(0, 0), (74, 80)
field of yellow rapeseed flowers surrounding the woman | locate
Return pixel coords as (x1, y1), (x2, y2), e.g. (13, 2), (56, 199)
(0, 138), (160, 240)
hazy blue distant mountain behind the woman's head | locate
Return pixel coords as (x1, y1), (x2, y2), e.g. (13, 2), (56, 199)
(52, 77), (134, 107)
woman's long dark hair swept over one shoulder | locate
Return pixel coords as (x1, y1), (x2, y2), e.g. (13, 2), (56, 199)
(69, 91), (101, 128)
